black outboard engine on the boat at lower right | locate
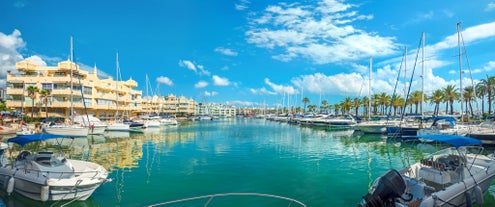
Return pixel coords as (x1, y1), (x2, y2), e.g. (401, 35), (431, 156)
(359, 170), (406, 207)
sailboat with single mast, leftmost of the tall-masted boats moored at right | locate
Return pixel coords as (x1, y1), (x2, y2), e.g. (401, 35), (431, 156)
(355, 57), (400, 134)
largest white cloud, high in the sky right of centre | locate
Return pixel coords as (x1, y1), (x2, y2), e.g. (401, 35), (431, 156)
(245, 0), (396, 64)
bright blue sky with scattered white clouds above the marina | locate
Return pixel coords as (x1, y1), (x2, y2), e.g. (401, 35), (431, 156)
(0, 0), (495, 107)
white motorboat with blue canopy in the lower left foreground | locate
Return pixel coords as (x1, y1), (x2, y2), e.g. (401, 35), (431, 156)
(0, 134), (110, 201)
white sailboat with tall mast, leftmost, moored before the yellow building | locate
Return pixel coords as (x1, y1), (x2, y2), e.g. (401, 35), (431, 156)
(43, 37), (89, 137)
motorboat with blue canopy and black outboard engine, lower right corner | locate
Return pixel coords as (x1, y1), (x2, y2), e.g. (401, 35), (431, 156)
(359, 135), (495, 207)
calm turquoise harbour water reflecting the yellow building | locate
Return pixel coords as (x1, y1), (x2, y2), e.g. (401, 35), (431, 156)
(0, 119), (494, 206)
